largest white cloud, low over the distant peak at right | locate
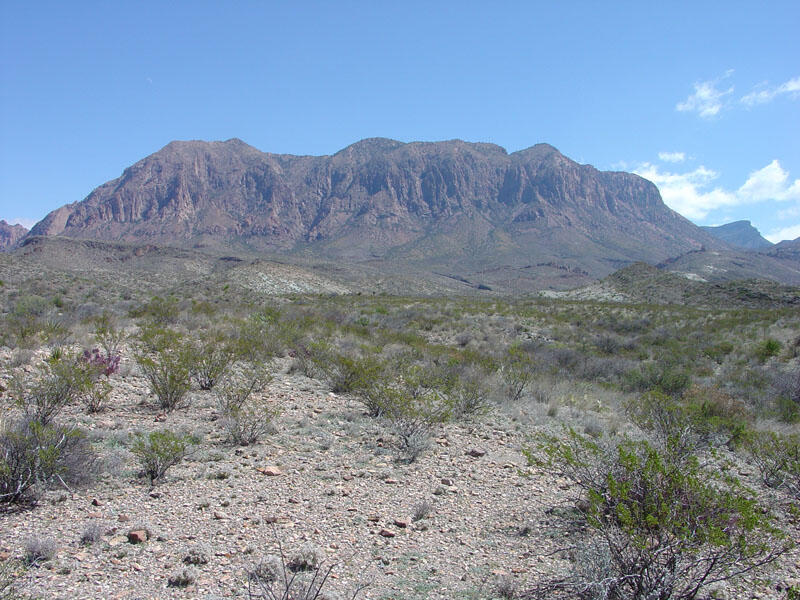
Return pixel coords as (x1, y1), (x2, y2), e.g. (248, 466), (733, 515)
(633, 160), (800, 219)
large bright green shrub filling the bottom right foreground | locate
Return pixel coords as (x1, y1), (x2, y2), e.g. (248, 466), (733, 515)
(527, 431), (790, 600)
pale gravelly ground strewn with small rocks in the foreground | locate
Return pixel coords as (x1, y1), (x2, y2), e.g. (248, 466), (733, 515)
(0, 349), (800, 600)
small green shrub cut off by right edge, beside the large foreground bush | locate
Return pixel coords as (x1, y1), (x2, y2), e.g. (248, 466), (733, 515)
(744, 431), (800, 499)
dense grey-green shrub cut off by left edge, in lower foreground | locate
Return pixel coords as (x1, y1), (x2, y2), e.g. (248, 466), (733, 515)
(0, 421), (96, 503)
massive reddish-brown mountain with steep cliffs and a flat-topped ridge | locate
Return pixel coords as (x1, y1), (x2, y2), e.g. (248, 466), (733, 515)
(30, 138), (727, 287)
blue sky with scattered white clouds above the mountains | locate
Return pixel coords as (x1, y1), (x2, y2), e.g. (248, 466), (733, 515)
(0, 0), (800, 241)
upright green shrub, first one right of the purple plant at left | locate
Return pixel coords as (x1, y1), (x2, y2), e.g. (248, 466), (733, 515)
(134, 327), (192, 412)
